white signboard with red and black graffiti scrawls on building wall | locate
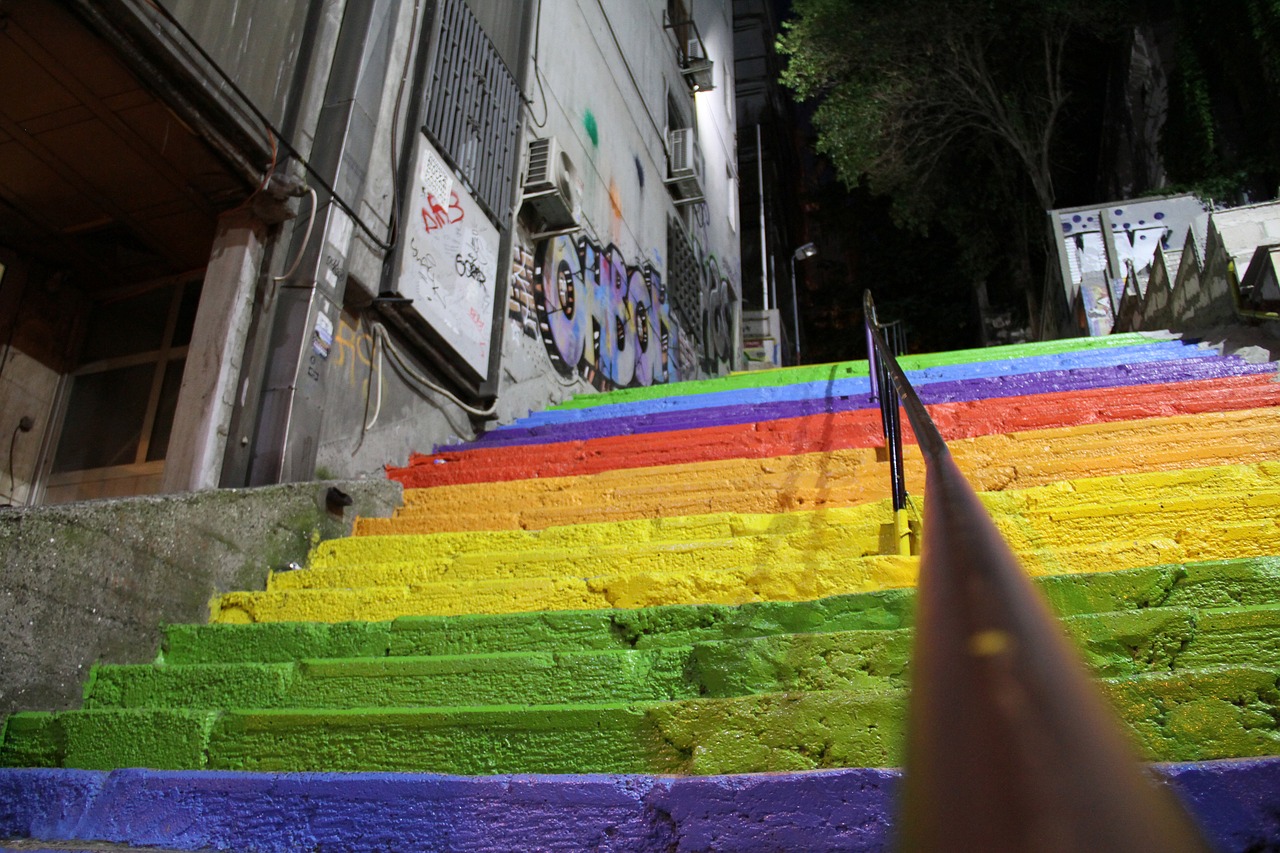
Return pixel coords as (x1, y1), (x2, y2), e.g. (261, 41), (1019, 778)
(397, 138), (499, 377)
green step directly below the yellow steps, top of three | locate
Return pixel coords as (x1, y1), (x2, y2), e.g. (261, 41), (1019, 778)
(161, 557), (1280, 663)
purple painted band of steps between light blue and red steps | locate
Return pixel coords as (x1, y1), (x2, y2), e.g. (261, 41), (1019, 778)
(455, 356), (1276, 452)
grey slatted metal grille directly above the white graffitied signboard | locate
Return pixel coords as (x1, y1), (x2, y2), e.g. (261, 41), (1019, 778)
(424, 0), (520, 228)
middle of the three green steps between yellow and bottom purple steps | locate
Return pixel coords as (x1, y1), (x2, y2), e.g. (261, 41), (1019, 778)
(84, 605), (1280, 710)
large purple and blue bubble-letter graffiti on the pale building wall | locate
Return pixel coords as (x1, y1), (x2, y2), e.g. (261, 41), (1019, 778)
(534, 236), (681, 389)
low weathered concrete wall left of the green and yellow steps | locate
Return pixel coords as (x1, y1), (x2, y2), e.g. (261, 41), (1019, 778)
(0, 480), (401, 715)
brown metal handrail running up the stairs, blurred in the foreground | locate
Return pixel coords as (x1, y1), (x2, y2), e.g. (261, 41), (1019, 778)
(864, 293), (1208, 853)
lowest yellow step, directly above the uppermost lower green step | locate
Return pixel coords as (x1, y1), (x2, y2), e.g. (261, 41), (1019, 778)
(225, 525), (1280, 621)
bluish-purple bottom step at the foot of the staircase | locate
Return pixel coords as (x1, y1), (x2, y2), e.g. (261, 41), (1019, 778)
(0, 758), (1280, 853)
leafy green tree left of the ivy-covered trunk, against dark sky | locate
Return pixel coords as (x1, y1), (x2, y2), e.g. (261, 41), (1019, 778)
(778, 0), (1129, 338)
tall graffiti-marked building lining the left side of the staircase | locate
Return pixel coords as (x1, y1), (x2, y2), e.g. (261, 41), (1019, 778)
(0, 0), (742, 505)
